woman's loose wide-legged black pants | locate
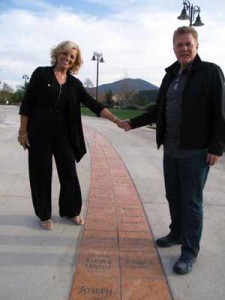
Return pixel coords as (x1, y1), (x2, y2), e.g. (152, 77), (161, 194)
(29, 115), (82, 221)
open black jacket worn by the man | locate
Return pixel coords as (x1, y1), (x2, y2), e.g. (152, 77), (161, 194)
(131, 55), (225, 156)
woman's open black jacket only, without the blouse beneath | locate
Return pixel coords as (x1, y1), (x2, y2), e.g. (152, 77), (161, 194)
(19, 67), (104, 162)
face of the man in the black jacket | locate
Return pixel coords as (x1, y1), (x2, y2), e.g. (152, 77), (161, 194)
(173, 33), (198, 68)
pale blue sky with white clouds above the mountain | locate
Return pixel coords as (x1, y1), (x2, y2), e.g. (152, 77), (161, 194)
(0, 0), (225, 89)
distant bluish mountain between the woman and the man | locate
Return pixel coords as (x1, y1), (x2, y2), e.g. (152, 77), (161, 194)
(90, 78), (159, 94)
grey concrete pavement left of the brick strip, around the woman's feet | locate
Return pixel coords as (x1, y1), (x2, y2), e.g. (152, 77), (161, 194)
(0, 106), (90, 300)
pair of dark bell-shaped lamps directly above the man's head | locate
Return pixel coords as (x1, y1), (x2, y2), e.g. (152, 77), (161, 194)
(177, 0), (204, 26)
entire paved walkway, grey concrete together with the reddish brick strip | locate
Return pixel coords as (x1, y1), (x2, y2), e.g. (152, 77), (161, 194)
(0, 106), (225, 300)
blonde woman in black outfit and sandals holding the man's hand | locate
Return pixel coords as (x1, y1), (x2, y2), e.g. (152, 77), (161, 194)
(18, 41), (121, 230)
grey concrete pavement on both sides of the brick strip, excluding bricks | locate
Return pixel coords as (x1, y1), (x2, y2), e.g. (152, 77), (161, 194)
(0, 106), (225, 300)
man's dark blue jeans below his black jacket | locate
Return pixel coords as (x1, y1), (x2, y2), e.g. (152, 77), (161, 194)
(163, 151), (209, 259)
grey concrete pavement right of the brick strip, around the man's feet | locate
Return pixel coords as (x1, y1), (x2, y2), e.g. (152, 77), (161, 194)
(85, 118), (225, 300)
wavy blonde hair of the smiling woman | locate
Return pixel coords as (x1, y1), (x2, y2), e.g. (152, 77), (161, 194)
(51, 41), (83, 74)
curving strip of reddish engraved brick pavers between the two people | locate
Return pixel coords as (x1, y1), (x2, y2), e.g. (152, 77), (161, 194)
(70, 127), (171, 300)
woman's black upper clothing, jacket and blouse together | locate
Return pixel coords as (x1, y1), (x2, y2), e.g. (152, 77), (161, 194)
(19, 66), (104, 161)
